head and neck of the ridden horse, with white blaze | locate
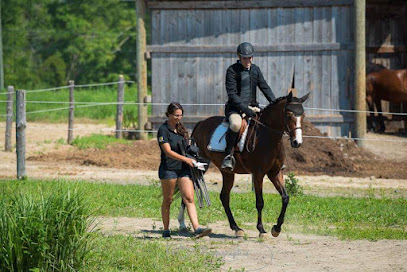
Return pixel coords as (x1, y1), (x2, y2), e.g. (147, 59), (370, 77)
(260, 92), (309, 148)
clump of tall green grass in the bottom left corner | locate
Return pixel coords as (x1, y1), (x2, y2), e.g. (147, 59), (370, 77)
(0, 184), (93, 271)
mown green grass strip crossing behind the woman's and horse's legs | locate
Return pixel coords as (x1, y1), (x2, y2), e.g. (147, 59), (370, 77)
(0, 180), (407, 240)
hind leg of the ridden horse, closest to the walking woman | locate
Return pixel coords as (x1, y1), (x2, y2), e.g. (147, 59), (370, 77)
(220, 171), (244, 237)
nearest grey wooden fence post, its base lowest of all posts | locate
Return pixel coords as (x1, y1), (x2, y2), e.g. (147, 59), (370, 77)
(16, 91), (27, 179)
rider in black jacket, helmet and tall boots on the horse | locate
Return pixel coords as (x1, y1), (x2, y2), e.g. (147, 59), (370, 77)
(222, 42), (275, 170)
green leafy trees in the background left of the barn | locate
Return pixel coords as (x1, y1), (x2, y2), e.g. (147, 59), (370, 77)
(2, 0), (142, 89)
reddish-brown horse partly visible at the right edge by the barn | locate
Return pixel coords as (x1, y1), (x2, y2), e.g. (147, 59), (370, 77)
(366, 64), (407, 133)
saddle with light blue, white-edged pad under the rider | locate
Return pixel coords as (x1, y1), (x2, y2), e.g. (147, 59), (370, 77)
(207, 118), (250, 152)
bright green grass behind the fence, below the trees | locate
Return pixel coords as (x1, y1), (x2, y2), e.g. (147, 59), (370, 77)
(0, 84), (144, 125)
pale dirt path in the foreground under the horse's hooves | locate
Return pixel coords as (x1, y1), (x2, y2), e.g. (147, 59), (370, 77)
(99, 217), (407, 272)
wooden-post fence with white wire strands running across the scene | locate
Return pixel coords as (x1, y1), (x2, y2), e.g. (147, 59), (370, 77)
(0, 79), (407, 179)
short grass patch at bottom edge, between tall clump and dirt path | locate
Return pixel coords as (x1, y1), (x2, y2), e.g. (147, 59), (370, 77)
(83, 234), (222, 271)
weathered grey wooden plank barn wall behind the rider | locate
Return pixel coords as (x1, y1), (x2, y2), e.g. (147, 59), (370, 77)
(150, 6), (354, 136)
